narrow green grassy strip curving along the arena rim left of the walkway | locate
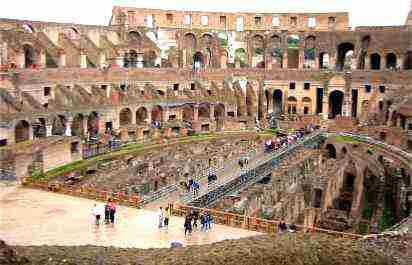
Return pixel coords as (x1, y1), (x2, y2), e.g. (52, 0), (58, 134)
(27, 132), (267, 181)
